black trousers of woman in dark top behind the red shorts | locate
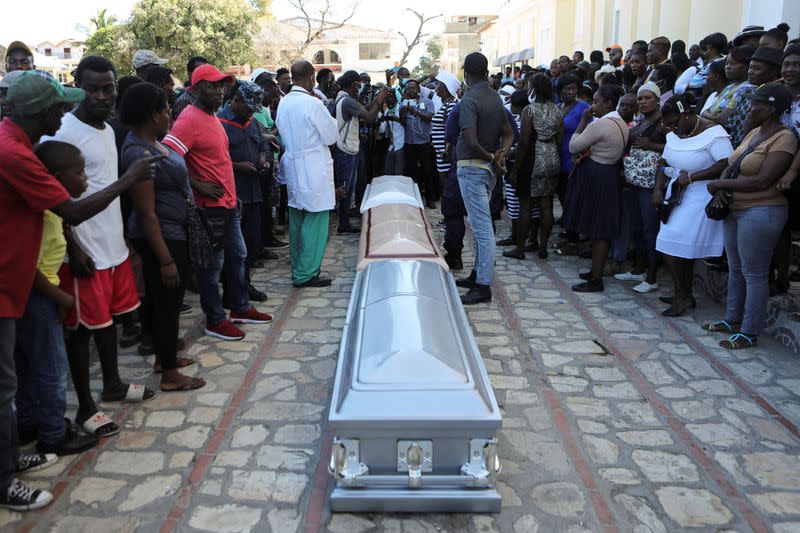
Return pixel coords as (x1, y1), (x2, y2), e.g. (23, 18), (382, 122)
(133, 239), (189, 370)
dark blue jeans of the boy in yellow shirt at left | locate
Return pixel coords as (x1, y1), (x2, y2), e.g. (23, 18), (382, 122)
(14, 289), (67, 445)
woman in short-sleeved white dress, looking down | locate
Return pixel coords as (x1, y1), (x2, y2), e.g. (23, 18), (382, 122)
(653, 92), (733, 316)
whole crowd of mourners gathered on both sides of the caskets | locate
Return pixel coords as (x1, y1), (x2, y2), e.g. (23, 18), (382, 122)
(0, 19), (800, 510)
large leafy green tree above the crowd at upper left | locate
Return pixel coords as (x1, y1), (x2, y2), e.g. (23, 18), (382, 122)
(126, 0), (259, 78)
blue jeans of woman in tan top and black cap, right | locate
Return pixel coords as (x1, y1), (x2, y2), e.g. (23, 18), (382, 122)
(723, 205), (788, 336)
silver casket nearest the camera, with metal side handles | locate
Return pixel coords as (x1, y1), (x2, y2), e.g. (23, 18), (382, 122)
(329, 260), (502, 512)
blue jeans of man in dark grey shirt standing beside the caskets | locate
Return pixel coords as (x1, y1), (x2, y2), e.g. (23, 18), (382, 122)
(456, 167), (497, 285)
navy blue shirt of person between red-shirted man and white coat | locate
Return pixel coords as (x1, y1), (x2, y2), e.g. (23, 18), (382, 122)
(217, 105), (270, 204)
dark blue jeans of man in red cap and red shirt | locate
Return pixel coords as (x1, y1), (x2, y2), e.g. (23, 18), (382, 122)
(197, 212), (250, 326)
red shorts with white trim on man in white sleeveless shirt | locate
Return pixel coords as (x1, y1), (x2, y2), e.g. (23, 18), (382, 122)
(58, 258), (139, 329)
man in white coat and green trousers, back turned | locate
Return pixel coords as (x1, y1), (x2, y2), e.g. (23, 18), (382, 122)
(275, 61), (339, 287)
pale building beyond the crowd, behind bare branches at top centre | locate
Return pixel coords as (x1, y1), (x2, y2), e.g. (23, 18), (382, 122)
(254, 17), (402, 83)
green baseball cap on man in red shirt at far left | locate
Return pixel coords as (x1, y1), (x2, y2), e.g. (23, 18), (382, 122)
(5, 70), (86, 115)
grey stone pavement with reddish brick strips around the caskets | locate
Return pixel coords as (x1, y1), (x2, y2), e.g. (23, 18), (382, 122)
(0, 211), (800, 533)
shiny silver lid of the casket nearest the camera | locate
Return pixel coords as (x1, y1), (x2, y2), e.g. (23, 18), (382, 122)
(330, 260), (500, 427)
